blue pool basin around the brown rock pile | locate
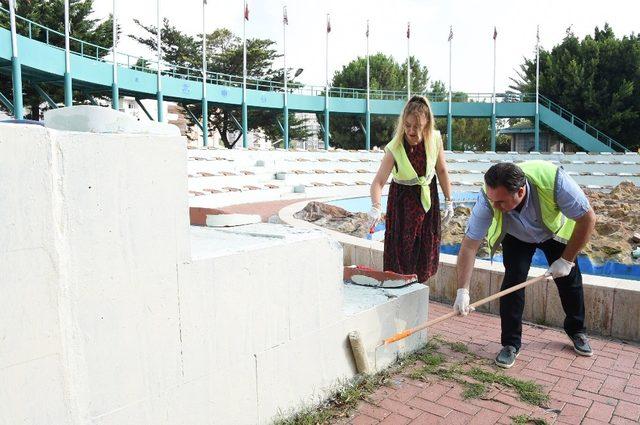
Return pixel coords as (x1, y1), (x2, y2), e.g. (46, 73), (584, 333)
(329, 192), (640, 280)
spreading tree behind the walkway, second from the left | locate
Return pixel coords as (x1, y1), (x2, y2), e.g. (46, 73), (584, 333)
(130, 23), (309, 148)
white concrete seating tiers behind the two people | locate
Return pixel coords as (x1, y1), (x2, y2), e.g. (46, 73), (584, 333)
(188, 149), (640, 207)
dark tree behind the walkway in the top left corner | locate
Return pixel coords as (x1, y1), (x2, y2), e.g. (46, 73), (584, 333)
(0, 0), (113, 120)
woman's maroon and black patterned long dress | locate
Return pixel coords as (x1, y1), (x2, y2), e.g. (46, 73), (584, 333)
(384, 140), (440, 282)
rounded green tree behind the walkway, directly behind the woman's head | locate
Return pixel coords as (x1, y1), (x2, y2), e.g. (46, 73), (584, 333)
(318, 53), (436, 149)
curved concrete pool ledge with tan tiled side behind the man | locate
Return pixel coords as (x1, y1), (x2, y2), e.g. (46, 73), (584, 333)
(279, 198), (640, 341)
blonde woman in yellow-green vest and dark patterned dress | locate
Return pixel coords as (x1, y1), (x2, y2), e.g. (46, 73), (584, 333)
(369, 96), (454, 282)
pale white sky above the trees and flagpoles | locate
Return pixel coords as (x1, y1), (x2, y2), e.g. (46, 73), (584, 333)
(94, 0), (640, 93)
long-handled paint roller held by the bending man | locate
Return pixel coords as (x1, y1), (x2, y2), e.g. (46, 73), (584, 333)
(349, 275), (553, 374)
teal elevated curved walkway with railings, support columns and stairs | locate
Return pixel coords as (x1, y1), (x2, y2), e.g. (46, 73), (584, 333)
(0, 6), (627, 152)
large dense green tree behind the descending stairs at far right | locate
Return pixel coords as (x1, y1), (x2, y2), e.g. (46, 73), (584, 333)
(511, 24), (640, 150)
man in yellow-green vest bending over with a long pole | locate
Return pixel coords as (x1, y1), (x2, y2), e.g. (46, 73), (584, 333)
(453, 161), (596, 368)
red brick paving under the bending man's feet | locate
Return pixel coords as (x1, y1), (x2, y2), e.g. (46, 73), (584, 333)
(339, 302), (640, 425)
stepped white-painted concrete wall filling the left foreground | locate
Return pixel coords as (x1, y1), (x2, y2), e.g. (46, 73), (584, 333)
(0, 125), (428, 425)
